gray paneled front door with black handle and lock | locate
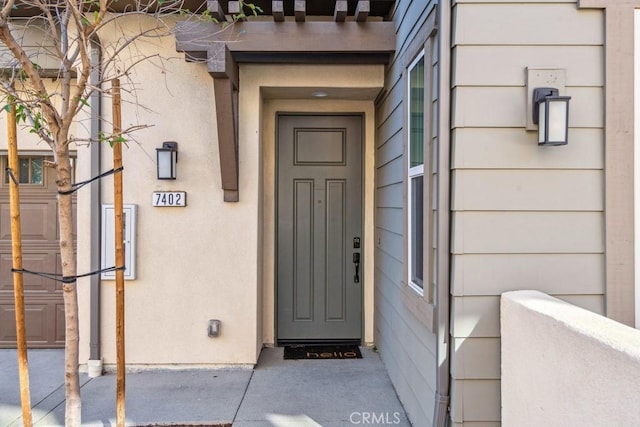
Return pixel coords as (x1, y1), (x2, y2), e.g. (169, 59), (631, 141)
(277, 114), (363, 342)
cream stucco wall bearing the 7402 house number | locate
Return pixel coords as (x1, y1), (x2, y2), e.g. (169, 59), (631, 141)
(90, 17), (259, 364)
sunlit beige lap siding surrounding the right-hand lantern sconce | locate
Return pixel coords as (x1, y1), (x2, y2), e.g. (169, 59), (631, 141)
(451, 0), (604, 426)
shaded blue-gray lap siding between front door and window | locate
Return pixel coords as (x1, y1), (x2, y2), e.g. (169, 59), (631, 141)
(375, 0), (437, 426)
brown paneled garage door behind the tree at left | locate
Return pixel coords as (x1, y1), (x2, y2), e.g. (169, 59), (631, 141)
(0, 156), (75, 348)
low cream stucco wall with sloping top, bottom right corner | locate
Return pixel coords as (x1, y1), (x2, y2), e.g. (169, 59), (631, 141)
(500, 291), (640, 427)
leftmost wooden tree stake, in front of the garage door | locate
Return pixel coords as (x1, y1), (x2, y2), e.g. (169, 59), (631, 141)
(7, 98), (33, 427)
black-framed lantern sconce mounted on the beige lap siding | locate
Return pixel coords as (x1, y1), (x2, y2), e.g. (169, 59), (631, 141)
(533, 87), (571, 145)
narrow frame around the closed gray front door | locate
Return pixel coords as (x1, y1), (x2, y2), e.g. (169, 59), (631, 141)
(273, 110), (369, 344)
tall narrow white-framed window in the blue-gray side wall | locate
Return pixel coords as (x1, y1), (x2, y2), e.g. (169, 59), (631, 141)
(407, 52), (425, 294)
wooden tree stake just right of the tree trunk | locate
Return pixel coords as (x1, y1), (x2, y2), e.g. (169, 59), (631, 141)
(111, 79), (126, 427)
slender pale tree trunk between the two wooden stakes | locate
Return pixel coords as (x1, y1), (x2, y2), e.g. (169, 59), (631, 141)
(55, 142), (82, 427)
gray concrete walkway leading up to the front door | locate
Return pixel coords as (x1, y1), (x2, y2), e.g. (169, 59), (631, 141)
(0, 348), (410, 427)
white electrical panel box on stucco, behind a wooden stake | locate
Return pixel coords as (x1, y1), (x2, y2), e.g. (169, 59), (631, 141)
(100, 205), (136, 280)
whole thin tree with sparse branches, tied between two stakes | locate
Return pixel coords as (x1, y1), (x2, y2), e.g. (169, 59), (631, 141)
(0, 0), (259, 426)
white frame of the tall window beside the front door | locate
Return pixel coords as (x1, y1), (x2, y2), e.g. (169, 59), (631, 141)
(406, 49), (429, 296)
